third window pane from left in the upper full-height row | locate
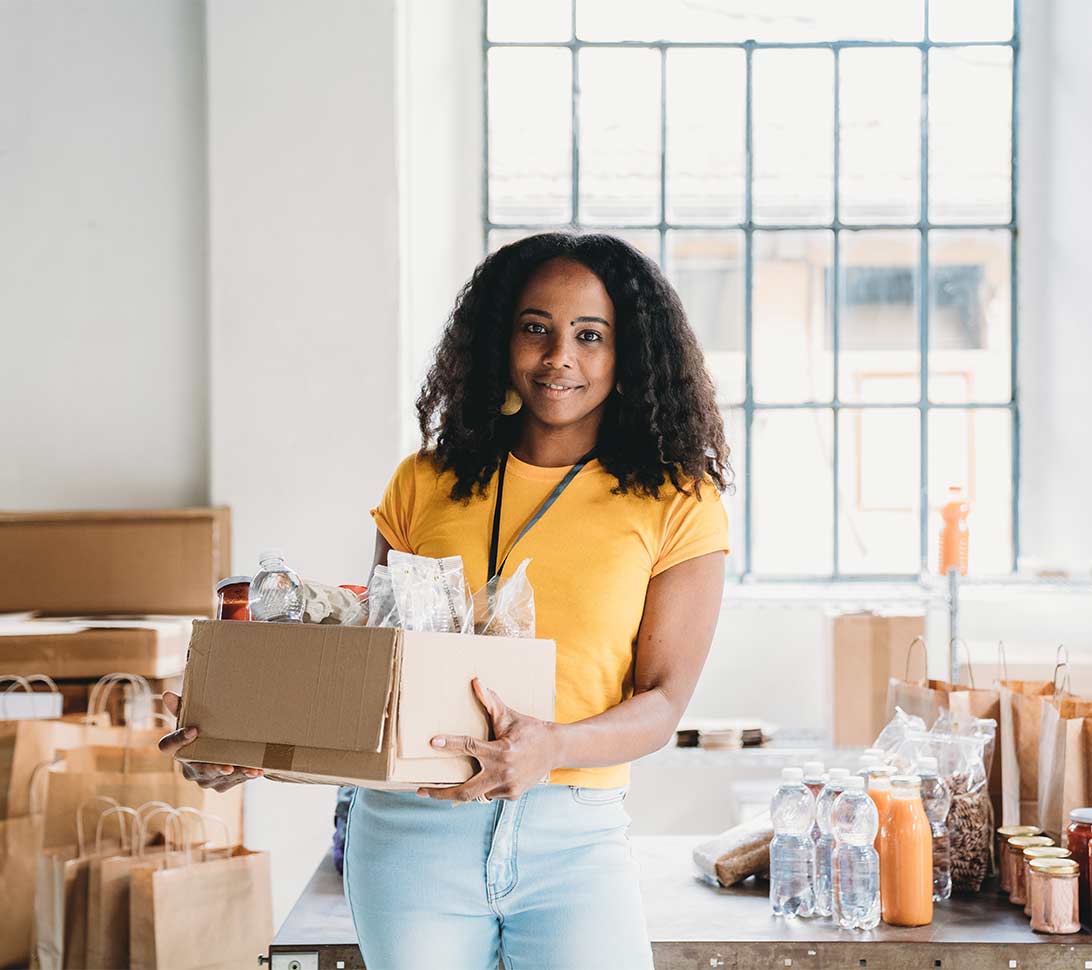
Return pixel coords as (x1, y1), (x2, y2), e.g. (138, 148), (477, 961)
(667, 49), (747, 224)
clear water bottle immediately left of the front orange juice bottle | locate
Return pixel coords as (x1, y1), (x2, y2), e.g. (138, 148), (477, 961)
(831, 776), (880, 930)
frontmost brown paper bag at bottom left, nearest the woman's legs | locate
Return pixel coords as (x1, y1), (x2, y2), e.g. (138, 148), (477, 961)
(129, 847), (273, 970)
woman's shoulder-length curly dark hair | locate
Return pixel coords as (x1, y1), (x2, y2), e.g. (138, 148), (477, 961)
(417, 233), (733, 500)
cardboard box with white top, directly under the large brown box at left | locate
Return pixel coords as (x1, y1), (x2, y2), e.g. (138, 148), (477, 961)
(0, 616), (193, 681)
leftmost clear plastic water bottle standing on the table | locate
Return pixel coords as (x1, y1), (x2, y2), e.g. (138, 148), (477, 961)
(770, 768), (816, 918)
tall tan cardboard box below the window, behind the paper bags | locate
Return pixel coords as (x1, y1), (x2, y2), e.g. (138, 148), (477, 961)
(831, 613), (926, 747)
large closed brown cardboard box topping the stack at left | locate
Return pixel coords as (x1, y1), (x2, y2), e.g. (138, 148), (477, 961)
(0, 508), (232, 611)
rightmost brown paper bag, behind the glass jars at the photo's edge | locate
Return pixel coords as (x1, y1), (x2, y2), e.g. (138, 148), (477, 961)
(1036, 696), (1092, 839)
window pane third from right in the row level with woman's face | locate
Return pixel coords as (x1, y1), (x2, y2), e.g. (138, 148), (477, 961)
(751, 229), (834, 403)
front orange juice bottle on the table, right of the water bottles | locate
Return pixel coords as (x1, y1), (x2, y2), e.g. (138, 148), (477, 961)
(880, 774), (933, 926)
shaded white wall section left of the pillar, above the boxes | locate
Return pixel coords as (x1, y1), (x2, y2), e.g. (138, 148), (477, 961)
(0, 0), (209, 509)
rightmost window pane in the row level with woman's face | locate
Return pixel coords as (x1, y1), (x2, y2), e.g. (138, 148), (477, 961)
(929, 229), (1012, 403)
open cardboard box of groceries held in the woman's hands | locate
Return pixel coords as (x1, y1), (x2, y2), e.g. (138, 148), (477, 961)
(178, 620), (555, 789)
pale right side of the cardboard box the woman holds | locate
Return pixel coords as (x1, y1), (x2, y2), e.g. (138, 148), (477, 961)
(396, 631), (555, 759)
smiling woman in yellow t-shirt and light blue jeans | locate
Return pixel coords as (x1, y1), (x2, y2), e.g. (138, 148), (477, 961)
(158, 233), (728, 970)
